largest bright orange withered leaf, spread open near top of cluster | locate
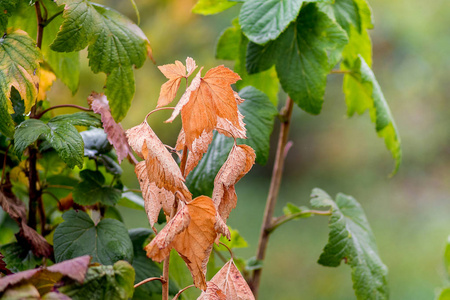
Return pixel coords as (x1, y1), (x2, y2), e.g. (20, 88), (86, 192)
(166, 66), (245, 150)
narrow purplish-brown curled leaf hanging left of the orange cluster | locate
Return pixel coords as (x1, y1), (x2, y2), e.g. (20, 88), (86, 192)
(88, 92), (134, 163)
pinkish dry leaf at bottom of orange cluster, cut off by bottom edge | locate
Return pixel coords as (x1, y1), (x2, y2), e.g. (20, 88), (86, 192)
(198, 259), (255, 300)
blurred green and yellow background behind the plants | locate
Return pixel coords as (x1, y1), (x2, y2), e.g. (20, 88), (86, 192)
(49, 0), (450, 300)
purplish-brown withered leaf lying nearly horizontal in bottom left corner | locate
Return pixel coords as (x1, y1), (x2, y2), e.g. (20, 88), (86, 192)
(0, 255), (91, 291)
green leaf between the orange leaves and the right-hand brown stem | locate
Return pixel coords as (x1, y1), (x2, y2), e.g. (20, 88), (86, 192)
(239, 86), (278, 165)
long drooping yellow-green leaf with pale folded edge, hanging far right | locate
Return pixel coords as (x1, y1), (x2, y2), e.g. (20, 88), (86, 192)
(344, 56), (402, 174)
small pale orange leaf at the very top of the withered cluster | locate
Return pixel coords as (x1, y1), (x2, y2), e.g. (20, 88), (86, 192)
(157, 57), (197, 107)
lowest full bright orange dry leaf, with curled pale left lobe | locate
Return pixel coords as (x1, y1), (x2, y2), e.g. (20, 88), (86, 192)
(145, 196), (225, 290)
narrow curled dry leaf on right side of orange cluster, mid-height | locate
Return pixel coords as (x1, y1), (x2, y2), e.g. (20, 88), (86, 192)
(212, 145), (256, 220)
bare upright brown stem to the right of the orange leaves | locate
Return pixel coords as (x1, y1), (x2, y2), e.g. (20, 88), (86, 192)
(250, 97), (294, 299)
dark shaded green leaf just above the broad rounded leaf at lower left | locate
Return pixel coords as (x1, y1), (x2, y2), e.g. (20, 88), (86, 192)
(73, 170), (122, 205)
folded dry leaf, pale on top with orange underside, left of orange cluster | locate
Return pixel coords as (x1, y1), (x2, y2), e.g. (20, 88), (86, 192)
(126, 121), (192, 200)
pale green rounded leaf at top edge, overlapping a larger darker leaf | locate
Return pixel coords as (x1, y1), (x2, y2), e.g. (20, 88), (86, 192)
(239, 0), (303, 44)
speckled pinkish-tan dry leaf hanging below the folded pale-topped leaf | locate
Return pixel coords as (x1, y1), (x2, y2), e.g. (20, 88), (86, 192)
(134, 161), (175, 227)
